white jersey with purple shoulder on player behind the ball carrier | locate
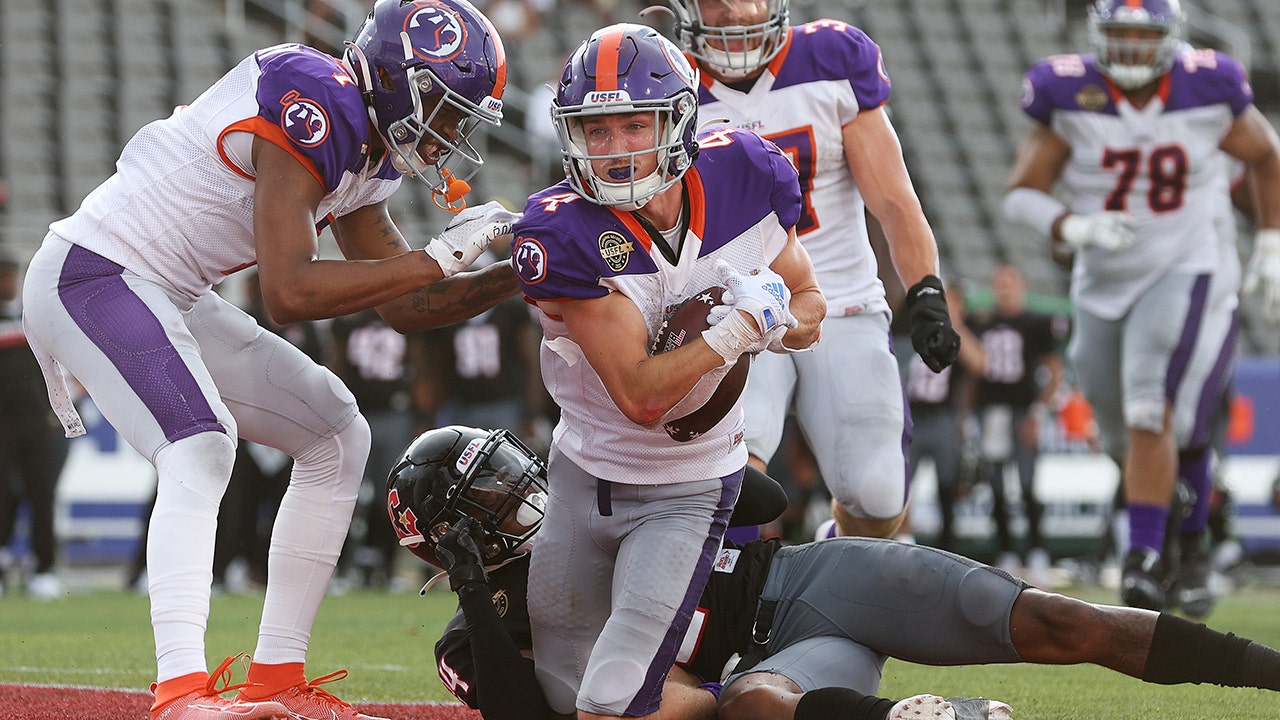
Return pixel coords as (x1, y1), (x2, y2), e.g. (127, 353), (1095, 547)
(698, 20), (890, 316)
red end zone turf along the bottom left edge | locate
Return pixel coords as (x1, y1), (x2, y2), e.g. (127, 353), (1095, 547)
(0, 684), (480, 720)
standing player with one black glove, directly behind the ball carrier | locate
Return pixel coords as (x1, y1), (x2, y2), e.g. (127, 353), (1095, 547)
(669, 0), (960, 537)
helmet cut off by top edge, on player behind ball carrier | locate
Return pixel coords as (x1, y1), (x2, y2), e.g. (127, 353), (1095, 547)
(667, 0), (791, 79)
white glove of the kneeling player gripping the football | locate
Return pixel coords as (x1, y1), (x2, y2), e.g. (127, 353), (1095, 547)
(703, 260), (797, 363)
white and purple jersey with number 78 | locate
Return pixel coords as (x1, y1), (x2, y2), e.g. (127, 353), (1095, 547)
(1023, 50), (1253, 320)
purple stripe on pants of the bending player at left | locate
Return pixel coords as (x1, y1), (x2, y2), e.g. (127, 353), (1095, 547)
(58, 246), (227, 442)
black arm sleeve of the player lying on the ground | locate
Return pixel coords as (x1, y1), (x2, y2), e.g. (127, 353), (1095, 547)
(458, 585), (552, 720)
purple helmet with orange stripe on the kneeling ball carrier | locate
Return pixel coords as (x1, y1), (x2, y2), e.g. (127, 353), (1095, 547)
(552, 23), (698, 210)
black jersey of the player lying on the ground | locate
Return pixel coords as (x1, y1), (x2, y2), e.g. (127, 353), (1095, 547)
(435, 539), (781, 717)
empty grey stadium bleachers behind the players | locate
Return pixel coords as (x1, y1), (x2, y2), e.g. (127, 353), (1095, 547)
(0, 0), (1280, 340)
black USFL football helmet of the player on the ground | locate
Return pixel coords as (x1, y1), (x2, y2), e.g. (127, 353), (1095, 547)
(387, 425), (547, 568)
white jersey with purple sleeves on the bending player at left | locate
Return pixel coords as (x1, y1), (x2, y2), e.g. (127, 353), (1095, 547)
(50, 45), (401, 300)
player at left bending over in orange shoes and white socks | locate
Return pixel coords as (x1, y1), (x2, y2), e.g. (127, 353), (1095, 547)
(24, 0), (517, 720)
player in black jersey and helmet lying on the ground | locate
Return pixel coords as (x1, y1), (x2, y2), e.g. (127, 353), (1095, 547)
(387, 427), (1280, 720)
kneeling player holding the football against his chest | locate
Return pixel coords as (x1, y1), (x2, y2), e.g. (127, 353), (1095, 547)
(512, 24), (826, 717)
